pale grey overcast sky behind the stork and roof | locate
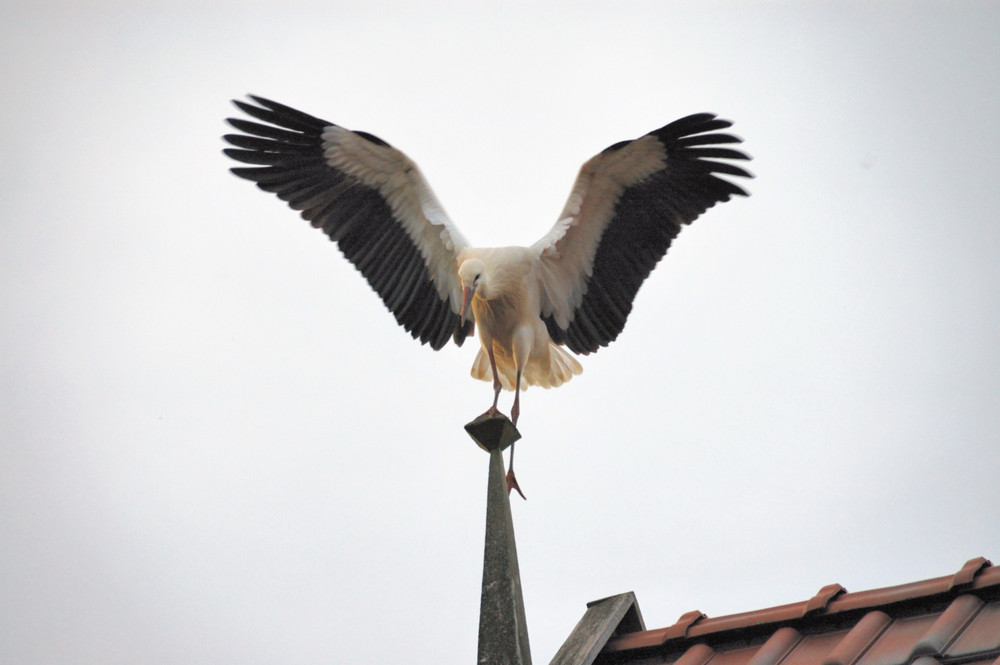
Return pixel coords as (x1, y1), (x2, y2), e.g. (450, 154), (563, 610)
(0, 0), (1000, 665)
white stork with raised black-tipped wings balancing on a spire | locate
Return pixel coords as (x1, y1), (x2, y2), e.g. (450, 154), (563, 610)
(223, 96), (752, 491)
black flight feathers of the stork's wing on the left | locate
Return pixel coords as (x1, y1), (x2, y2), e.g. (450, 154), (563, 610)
(223, 95), (460, 350)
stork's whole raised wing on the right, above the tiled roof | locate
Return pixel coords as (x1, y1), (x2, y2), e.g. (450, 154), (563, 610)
(533, 113), (752, 353)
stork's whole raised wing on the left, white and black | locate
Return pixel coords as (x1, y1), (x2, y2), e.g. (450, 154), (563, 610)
(223, 96), (473, 349)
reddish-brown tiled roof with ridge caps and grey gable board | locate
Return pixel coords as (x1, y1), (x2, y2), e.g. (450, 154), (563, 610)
(552, 558), (1000, 665)
